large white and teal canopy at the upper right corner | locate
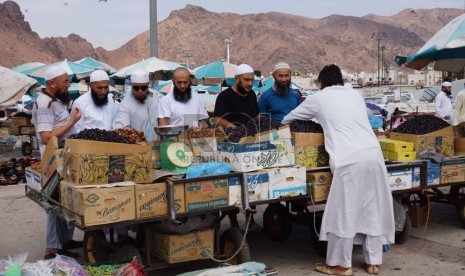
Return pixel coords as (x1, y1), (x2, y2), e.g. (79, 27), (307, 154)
(395, 14), (465, 72)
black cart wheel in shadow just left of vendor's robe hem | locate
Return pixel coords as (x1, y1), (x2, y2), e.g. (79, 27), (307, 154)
(263, 203), (292, 241)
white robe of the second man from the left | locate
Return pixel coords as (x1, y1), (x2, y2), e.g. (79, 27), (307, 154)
(73, 90), (116, 132)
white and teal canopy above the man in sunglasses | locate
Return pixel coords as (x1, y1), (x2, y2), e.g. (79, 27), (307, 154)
(111, 57), (183, 79)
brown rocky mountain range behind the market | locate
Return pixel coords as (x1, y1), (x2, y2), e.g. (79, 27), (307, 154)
(0, 1), (462, 74)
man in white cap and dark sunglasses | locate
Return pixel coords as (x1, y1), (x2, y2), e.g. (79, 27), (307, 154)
(113, 69), (158, 141)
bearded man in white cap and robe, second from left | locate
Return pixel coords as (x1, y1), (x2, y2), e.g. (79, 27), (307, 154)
(73, 70), (116, 132)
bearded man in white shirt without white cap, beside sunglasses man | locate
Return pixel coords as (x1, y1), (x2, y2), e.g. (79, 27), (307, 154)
(158, 67), (208, 126)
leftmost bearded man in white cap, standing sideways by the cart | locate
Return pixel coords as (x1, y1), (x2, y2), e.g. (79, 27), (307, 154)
(32, 66), (82, 259)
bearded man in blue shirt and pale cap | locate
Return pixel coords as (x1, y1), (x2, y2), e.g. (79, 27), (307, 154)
(258, 62), (300, 122)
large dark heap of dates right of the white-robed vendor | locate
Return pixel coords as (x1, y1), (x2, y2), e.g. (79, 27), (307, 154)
(394, 115), (450, 135)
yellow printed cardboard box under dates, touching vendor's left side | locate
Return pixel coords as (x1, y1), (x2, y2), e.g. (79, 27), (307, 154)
(292, 132), (329, 169)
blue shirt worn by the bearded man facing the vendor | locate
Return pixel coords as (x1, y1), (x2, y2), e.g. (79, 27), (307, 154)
(258, 87), (300, 122)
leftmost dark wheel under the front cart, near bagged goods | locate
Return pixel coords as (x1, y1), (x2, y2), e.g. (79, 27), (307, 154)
(84, 230), (108, 263)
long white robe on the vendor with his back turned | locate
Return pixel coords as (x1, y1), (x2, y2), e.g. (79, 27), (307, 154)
(283, 86), (395, 244)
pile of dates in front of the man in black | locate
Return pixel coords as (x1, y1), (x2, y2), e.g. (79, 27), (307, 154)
(226, 117), (283, 143)
